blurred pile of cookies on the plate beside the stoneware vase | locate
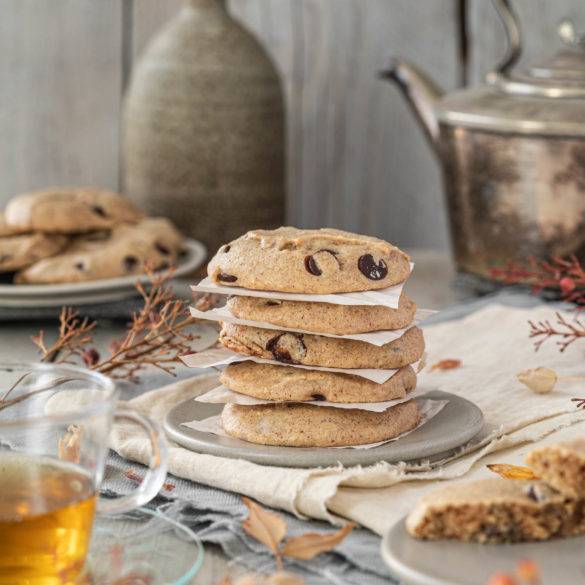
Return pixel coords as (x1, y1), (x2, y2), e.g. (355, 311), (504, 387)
(0, 188), (183, 284)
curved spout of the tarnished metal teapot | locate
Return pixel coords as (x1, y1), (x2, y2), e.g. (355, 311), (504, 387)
(380, 59), (444, 153)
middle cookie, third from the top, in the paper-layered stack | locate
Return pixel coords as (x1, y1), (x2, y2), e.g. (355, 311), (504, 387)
(219, 323), (425, 369)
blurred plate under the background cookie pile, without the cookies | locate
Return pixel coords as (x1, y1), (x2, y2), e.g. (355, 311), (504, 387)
(0, 239), (207, 307)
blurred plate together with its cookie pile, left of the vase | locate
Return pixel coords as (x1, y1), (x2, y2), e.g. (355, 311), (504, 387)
(0, 187), (207, 308)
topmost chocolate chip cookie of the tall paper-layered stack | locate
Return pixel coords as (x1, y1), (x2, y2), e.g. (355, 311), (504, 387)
(208, 227), (410, 293)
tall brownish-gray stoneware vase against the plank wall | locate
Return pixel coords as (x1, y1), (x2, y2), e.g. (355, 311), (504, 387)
(124, 0), (285, 254)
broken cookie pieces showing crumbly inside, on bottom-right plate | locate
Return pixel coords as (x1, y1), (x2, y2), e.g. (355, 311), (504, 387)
(406, 439), (585, 544)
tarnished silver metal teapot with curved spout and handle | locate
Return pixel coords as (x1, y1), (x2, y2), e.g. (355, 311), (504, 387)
(381, 0), (585, 281)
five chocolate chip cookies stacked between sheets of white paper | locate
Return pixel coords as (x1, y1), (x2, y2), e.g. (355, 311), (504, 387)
(195, 227), (424, 447)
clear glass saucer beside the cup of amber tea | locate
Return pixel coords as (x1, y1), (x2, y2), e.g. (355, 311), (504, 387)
(86, 508), (203, 585)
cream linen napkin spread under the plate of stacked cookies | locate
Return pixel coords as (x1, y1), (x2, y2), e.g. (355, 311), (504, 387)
(107, 304), (585, 534)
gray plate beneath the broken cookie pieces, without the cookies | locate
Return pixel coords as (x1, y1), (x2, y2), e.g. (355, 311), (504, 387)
(381, 520), (585, 585)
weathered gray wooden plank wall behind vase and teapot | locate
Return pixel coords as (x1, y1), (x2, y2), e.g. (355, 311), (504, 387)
(0, 0), (585, 248)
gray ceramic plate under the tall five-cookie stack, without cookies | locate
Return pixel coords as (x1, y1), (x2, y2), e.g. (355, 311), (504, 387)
(164, 391), (483, 467)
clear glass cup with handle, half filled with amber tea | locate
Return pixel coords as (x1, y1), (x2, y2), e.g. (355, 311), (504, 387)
(0, 364), (166, 585)
